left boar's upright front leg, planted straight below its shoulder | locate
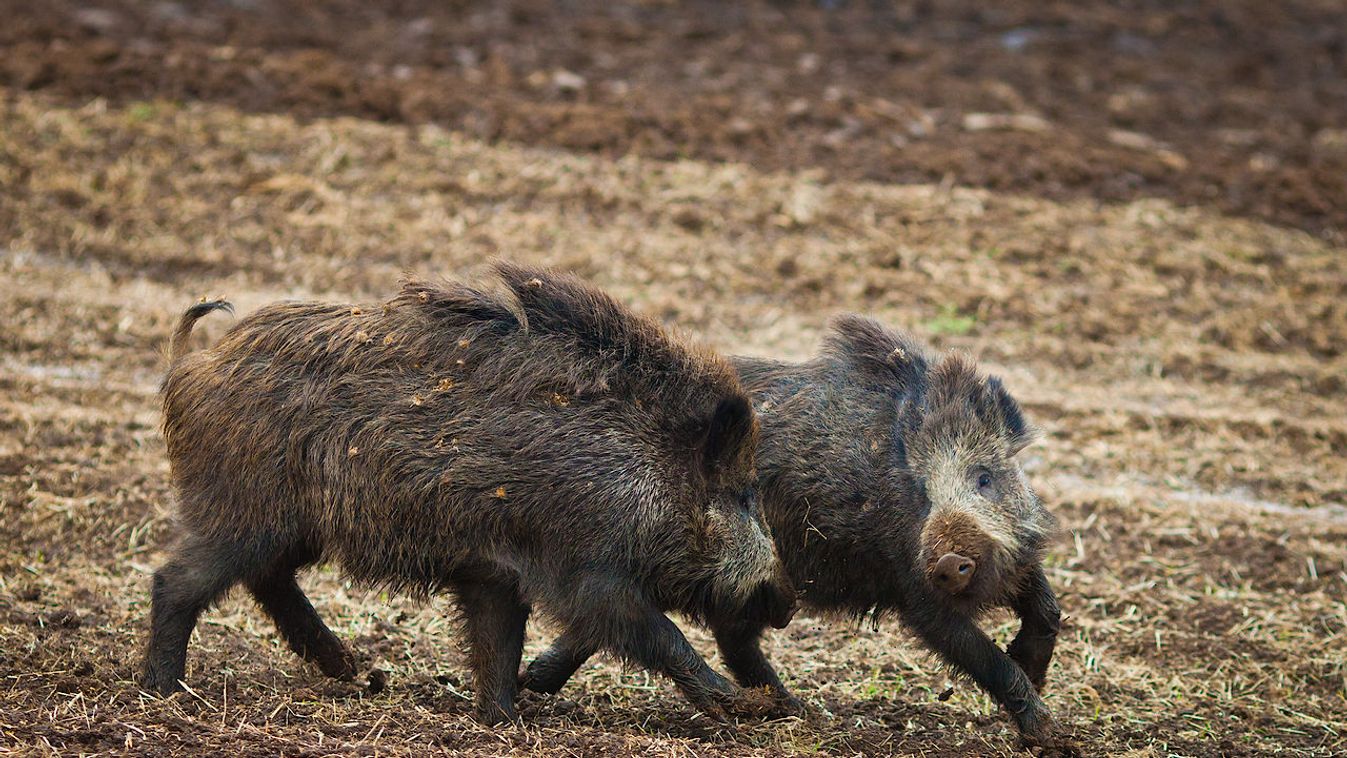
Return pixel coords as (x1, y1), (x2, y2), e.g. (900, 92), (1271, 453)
(458, 582), (529, 724)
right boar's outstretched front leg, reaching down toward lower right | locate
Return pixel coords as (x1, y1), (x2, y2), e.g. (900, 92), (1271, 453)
(905, 599), (1059, 747)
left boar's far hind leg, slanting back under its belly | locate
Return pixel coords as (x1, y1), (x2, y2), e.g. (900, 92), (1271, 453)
(248, 551), (356, 680)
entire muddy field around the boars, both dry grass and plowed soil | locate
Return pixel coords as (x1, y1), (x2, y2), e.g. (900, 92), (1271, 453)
(0, 0), (1347, 755)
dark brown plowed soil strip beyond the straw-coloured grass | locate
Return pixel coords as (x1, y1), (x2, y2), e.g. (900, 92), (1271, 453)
(0, 0), (1347, 240)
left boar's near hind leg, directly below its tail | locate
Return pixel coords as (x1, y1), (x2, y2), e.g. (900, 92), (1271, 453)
(141, 536), (261, 695)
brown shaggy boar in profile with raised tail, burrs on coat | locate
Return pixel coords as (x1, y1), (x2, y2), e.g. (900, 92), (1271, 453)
(144, 264), (793, 723)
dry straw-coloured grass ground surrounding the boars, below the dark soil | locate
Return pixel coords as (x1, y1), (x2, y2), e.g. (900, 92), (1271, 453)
(0, 96), (1347, 755)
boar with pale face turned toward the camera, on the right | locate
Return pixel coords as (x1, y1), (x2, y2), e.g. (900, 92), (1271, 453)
(525, 316), (1060, 745)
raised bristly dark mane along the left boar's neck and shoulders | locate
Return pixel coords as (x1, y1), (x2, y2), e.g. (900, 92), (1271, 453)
(389, 263), (746, 428)
